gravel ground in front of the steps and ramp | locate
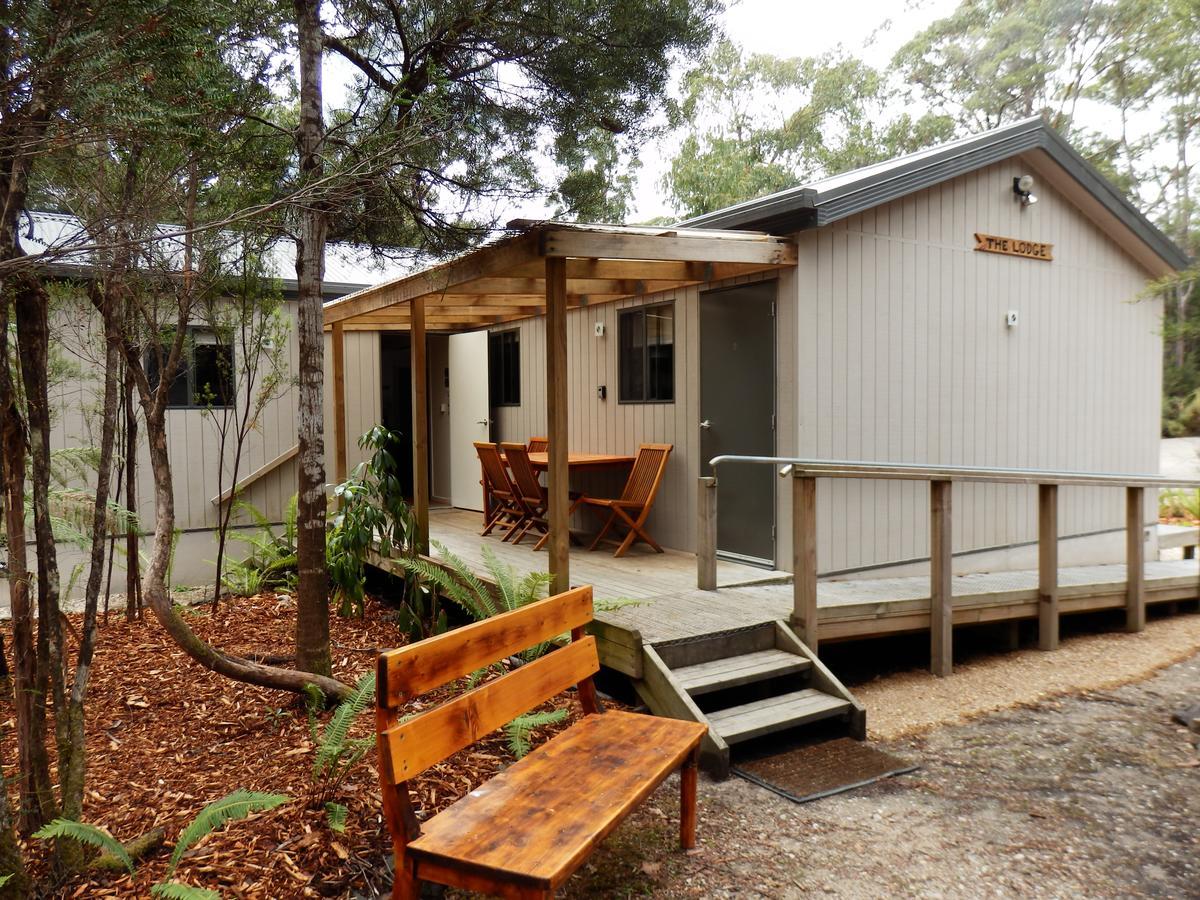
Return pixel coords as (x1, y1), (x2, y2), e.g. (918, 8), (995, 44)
(566, 636), (1200, 899)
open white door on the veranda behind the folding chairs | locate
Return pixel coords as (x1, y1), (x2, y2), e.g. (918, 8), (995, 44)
(449, 331), (491, 510)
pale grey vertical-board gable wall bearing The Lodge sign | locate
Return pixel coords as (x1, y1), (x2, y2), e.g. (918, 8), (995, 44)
(782, 160), (1162, 571)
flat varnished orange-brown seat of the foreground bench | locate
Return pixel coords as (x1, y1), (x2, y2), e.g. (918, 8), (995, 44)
(408, 710), (706, 896)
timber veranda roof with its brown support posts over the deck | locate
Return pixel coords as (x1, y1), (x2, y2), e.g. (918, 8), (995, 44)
(325, 222), (797, 590)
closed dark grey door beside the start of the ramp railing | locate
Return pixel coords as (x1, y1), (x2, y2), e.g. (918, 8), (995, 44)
(700, 281), (775, 564)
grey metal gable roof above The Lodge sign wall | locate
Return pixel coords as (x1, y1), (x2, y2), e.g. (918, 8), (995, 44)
(682, 116), (1190, 269)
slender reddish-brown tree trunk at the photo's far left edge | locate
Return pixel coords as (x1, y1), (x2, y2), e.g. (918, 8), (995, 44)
(0, 294), (55, 835)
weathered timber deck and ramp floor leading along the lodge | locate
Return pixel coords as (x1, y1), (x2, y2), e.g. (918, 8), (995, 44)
(396, 509), (1200, 678)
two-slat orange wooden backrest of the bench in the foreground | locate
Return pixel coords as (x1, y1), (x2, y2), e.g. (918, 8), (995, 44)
(376, 586), (600, 785)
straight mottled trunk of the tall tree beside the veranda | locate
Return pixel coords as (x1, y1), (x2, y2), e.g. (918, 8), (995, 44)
(295, 0), (330, 674)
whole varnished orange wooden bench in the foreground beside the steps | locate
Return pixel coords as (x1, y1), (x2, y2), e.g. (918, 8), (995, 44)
(376, 587), (707, 899)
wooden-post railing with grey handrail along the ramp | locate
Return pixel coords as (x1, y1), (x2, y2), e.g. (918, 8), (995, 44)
(696, 456), (1200, 676)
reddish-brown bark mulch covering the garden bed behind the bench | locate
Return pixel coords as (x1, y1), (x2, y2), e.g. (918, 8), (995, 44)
(0, 594), (577, 899)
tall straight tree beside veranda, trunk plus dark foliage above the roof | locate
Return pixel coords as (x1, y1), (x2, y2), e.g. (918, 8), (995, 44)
(292, 0), (721, 673)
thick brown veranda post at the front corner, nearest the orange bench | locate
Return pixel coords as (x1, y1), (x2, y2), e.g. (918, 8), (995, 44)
(546, 257), (571, 593)
